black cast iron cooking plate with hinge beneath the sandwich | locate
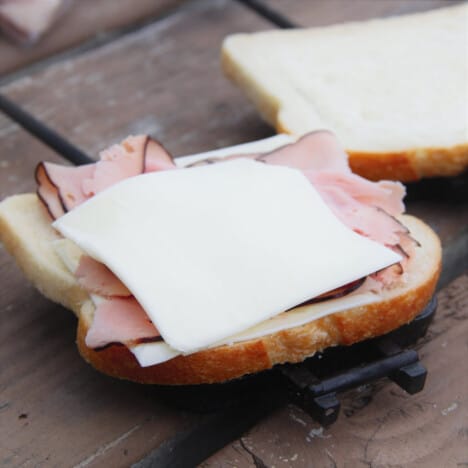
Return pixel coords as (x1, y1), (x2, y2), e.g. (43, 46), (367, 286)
(154, 297), (437, 425)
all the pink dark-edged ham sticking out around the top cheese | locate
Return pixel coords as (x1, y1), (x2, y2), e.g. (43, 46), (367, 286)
(36, 131), (415, 348)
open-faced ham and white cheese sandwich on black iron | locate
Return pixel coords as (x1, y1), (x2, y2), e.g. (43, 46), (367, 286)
(0, 131), (441, 385)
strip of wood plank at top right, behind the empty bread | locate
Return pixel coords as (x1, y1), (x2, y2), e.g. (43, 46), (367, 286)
(264, 0), (460, 27)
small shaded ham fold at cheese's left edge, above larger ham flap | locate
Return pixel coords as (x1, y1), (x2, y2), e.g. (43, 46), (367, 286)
(75, 255), (132, 297)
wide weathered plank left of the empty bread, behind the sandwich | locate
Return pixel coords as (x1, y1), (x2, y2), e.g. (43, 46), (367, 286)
(2, 1), (273, 159)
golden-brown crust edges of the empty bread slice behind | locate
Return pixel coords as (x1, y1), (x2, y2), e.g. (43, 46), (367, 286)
(221, 48), (468, 182)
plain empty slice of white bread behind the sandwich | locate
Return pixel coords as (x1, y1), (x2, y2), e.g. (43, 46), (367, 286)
(222, 3), (468, 181)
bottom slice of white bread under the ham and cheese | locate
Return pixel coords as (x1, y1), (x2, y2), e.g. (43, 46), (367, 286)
(0, 194), (441, 385)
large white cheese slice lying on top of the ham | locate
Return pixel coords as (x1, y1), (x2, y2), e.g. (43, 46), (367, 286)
(54, 159), (401, 353)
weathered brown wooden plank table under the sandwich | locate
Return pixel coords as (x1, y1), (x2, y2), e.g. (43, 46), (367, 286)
(0, 0), (468, 467)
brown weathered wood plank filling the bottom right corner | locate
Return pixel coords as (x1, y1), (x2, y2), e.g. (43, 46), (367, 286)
(201, 275), (468, 468)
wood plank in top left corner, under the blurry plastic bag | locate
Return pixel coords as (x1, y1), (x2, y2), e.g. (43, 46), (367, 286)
(0, 0), (182, 76)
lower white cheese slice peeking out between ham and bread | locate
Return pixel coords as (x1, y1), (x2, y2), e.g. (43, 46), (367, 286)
(129, 292), (380, 367)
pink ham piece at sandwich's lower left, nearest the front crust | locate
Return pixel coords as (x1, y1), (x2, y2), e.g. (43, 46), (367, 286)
(86, 297), (159, 348)
